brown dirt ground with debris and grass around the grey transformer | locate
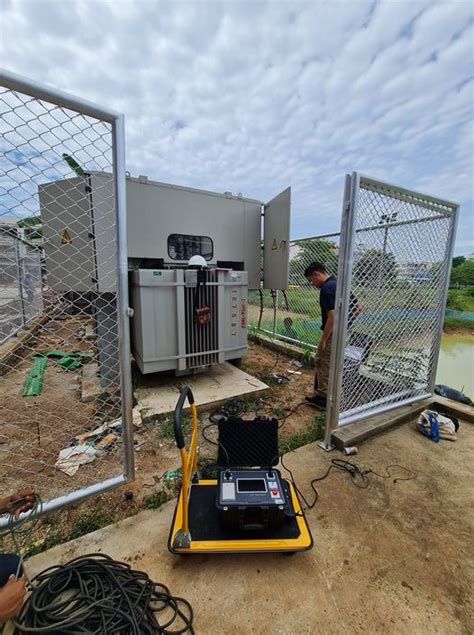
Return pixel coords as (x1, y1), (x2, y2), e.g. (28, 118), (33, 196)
(0, 338), (318, 553)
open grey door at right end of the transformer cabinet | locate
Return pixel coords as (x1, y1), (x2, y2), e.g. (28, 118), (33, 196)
(263, 187), (291, 289)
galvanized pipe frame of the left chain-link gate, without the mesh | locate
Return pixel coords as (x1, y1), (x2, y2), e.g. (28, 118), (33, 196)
(0, 69), (135, 527)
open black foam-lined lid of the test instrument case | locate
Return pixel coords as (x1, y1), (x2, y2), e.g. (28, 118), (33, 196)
(217, 417), (280, 469)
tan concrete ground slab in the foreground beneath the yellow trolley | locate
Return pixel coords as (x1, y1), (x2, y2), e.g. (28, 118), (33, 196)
(26, 425), (474, 635)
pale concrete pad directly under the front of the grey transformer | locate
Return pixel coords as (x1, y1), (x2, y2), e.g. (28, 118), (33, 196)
(135, 362), (268, 421)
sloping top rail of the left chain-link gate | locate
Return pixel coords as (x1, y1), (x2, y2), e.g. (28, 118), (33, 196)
(0, 69), (122, 124)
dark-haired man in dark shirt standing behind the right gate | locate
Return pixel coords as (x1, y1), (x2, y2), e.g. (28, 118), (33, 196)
(304, 262), (336, 409)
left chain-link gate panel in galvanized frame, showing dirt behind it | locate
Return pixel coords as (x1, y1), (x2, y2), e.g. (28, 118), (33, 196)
(0, 74), (134, 510)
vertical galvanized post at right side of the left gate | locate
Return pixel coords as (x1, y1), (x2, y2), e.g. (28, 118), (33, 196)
(112, 115), (135, 481)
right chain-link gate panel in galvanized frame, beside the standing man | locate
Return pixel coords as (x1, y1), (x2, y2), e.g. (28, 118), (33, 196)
(325, 173), (458, 446)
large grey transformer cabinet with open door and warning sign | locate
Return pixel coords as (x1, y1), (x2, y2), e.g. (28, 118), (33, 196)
(40, 173), (291, 374)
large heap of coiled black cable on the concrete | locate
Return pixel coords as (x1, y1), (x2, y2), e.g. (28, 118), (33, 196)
(14, 554), (194, 635)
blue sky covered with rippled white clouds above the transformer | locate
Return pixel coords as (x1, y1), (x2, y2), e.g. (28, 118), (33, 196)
(0, 0), (474, 253)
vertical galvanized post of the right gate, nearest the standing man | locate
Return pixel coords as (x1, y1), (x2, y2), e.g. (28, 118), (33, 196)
(320, 172), (359, 450)
